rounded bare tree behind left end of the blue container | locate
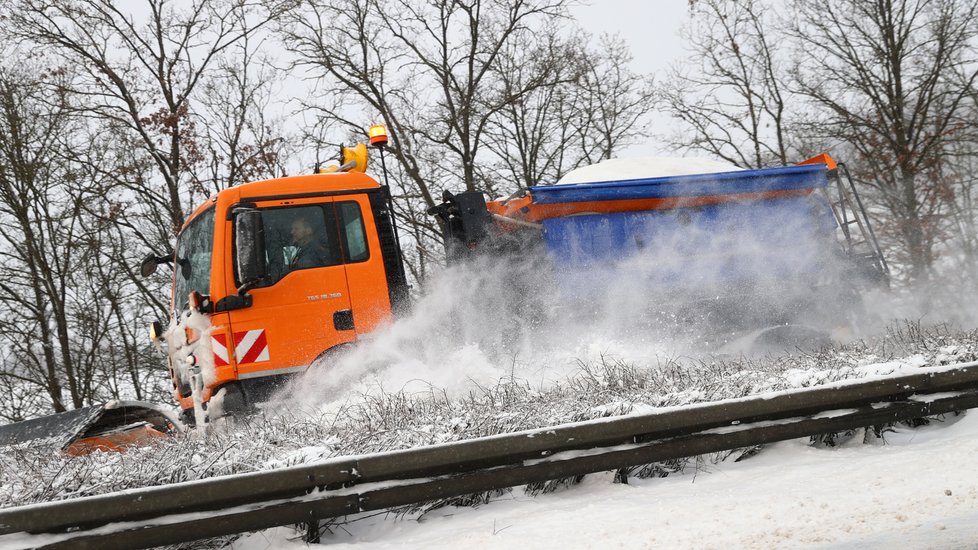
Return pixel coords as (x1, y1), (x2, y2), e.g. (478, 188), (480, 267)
(487, 34), (655, 187)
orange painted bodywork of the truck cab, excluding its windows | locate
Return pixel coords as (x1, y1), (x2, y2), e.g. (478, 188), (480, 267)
(171, 172), (392, 410)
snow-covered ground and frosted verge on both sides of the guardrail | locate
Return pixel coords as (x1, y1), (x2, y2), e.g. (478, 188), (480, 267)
(0, 314), (978, 550)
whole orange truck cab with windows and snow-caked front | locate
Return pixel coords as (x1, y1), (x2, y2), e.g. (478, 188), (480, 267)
(143, 162), (408, 423)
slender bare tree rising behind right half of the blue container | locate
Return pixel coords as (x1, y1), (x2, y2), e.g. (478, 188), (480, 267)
(662, 0), (788, 168)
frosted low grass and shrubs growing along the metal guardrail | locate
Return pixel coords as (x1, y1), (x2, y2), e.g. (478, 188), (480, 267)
(0, 322), (978, 528)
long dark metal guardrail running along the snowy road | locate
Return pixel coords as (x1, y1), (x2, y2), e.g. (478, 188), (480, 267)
(0, 363), (978, 549)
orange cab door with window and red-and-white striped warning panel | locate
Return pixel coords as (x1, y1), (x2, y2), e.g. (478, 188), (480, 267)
(228, 201), (356, 379)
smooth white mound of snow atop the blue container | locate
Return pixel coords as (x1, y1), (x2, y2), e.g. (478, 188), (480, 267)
(557, 157), (741, 185)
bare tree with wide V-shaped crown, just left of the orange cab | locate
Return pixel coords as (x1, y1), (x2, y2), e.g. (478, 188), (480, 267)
(8, 0), (289, 236)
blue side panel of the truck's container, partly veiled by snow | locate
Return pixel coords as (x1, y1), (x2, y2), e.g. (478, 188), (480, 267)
(544, 197), (835, 291)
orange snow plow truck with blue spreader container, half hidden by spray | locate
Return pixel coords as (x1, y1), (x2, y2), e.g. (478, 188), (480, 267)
(0, 127), (888, 452)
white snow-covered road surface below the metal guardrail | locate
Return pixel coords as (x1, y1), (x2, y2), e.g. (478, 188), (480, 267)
(232, 413), (978, 550)
